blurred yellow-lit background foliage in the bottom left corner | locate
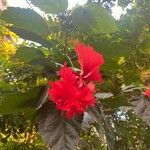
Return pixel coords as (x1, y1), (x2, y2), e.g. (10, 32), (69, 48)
(0, 113), (46, 150)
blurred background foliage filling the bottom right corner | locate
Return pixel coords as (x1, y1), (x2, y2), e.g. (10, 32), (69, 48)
(114, 112), (150, 150)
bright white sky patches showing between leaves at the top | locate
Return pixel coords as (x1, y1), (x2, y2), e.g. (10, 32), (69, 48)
(8, 0), (124, 19)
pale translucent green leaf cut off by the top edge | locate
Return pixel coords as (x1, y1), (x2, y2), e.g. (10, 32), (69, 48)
(30, 0), (68, 14)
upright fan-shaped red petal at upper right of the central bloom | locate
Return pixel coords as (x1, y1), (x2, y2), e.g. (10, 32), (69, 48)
(75, 43), (104, 81)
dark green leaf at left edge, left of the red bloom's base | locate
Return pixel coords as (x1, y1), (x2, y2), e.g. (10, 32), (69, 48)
(0, 88), (39, 114)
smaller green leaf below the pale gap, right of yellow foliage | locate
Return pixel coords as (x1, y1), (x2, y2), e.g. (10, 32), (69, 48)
(15, 47), (44, 63)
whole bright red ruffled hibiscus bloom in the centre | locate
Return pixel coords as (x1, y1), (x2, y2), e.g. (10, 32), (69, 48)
(49, 43), (104, 119)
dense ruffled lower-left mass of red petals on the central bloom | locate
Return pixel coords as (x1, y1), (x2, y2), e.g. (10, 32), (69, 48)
(49, 66), (95, 119)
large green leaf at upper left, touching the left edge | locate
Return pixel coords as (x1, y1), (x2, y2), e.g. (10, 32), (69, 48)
(0, 7), (48, 35)
